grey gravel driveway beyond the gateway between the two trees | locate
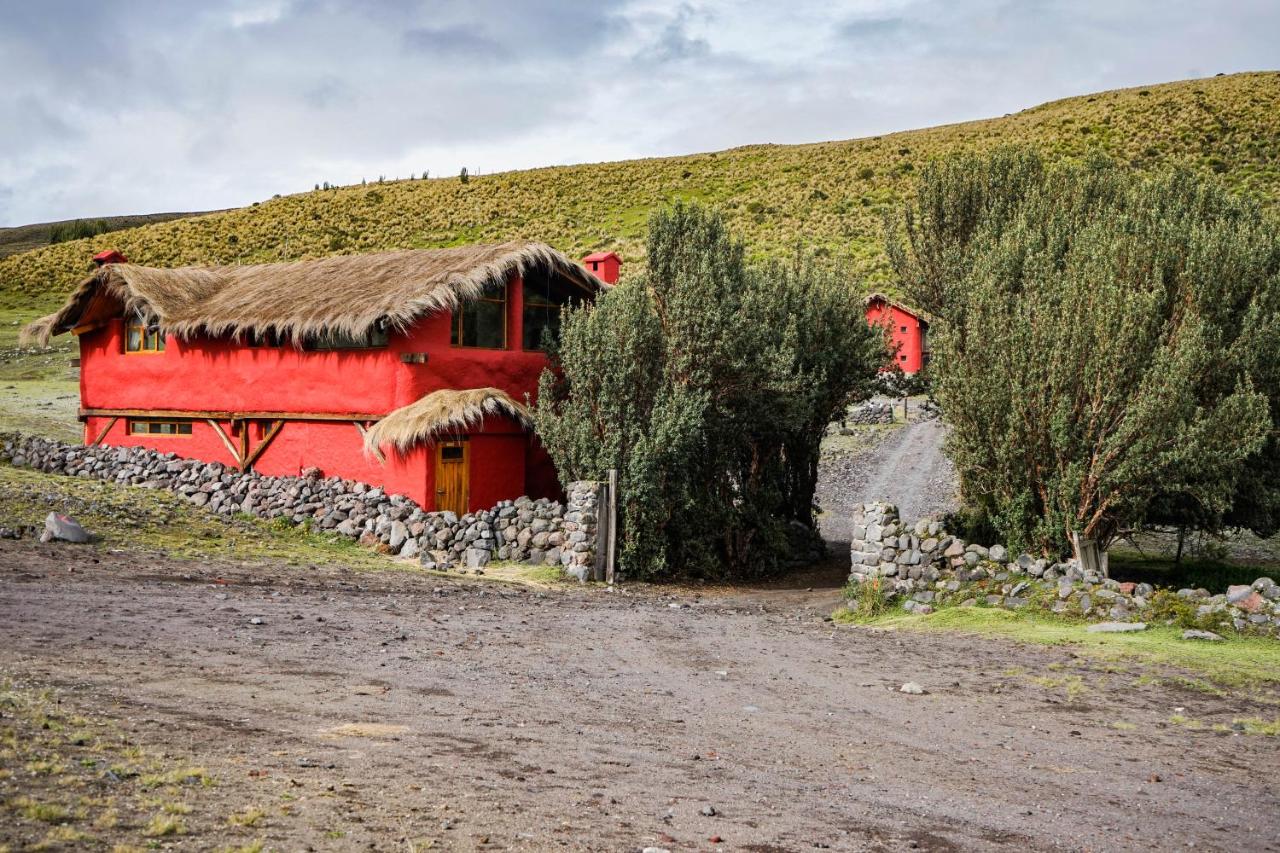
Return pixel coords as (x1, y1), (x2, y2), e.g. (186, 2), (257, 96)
(818, 419), (959, 542)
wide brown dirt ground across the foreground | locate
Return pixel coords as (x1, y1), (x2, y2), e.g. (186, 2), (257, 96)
(0, 542), (1280, 852)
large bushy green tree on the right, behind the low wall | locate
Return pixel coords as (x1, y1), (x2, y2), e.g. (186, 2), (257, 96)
(890, 151), (1280, 569)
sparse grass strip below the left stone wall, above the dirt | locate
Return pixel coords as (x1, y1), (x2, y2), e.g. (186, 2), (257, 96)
(0, 465), (404, 570)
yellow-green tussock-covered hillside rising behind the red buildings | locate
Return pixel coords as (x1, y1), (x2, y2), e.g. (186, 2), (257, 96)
(0, 72), (1280, 314)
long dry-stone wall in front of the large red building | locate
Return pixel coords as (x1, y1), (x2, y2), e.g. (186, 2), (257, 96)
(0, 433), (598, 579)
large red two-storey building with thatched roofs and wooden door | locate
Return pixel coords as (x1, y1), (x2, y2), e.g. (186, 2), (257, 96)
(27, 242), (604, 514)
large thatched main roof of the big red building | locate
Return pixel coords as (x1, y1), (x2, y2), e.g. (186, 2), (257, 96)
(23, 241), (604, 345)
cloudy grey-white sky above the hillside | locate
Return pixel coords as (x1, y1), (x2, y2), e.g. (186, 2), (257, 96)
(0, 0), (1280, 225)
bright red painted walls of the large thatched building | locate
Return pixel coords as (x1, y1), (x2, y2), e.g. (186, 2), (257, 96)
(79, 278), (561, 510)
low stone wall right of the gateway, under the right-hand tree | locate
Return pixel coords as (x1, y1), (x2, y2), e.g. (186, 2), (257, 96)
(849, 503), (1280, 635)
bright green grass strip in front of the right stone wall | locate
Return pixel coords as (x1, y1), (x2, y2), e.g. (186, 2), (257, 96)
(837, 607), (1280, 686)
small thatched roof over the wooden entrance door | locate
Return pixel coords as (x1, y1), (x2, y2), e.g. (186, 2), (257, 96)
(365, 388), (534, 453)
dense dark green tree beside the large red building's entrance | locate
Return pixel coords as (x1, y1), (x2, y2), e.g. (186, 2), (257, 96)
(535, 205), (884, 578)
